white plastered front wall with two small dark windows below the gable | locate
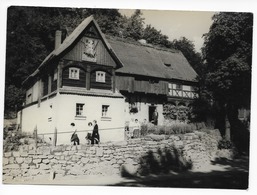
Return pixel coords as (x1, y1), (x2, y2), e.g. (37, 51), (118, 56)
(51, 94), (124, 144)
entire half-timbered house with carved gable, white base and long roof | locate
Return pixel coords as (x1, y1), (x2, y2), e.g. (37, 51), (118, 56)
(19, 16), (197, 144)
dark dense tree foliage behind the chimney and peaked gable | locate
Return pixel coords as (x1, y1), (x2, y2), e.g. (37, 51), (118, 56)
(6, 7), (121, 87)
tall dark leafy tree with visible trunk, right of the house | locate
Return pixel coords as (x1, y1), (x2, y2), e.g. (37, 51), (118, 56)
(203, 12), (253, 151)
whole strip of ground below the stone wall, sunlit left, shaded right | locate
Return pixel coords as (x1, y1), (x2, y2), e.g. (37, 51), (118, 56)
(4, 156), (249, 189)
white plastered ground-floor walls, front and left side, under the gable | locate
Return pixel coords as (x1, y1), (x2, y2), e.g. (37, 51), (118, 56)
(22, 94), (124, 145)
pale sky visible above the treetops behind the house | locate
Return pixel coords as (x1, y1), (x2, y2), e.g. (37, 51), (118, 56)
(120, 9), (215, 52)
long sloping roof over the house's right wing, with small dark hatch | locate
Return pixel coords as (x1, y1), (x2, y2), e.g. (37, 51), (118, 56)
(107, 37), (197, 81)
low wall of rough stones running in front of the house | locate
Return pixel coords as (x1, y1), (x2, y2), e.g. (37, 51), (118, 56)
(3, 130), (221, 182)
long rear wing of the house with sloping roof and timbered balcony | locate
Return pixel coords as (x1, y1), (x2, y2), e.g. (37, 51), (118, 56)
(108, 38), (198, 124)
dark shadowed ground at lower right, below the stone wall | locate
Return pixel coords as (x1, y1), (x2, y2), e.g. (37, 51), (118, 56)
(109, 157), (249, 189)
